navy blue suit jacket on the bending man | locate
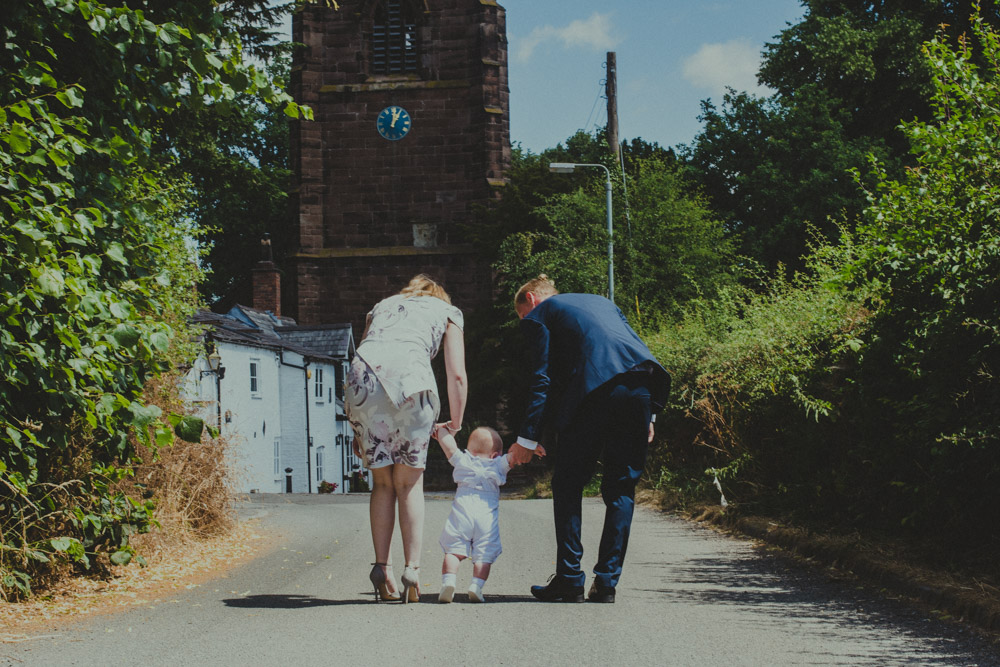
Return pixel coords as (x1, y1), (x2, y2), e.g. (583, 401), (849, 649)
(518, 294), (670, 441)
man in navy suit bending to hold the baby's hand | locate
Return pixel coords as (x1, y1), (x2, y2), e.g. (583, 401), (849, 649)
(509, 274), (670, 602)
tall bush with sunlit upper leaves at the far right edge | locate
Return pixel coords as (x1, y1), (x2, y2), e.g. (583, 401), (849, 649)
(840, 8), (1000, 538)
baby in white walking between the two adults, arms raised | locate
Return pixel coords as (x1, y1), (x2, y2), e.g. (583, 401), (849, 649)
(434, 424), (511, 602)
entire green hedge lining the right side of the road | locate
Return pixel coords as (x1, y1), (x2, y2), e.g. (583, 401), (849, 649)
(653, 13), (1000, 552)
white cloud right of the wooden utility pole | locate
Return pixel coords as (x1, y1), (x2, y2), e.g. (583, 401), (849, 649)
(681, 39), (766, 97)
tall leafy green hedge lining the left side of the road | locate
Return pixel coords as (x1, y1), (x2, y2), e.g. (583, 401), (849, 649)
(0, 0), (310, 598)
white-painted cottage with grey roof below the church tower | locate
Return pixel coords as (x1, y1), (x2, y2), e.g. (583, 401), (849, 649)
(187, 306), (371, 493)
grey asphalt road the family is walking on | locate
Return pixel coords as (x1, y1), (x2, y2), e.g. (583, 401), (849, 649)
(0, 496), (1000, 667)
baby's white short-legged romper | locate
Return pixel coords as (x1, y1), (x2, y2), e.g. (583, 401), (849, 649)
(438, 450), (510, 563)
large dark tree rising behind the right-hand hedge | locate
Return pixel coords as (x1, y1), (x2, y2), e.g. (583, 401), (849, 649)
(683, 0), (997, 268)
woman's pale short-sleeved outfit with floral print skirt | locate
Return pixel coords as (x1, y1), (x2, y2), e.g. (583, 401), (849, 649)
(346, 294), (464, 468)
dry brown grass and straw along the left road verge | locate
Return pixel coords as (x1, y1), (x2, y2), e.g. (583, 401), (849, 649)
(0, 374), (245, 641)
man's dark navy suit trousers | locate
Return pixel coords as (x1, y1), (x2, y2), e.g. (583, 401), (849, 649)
(552, 373), (651, 587)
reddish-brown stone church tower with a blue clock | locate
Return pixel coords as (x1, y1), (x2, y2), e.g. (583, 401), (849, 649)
(283, 0), (510, 335)
